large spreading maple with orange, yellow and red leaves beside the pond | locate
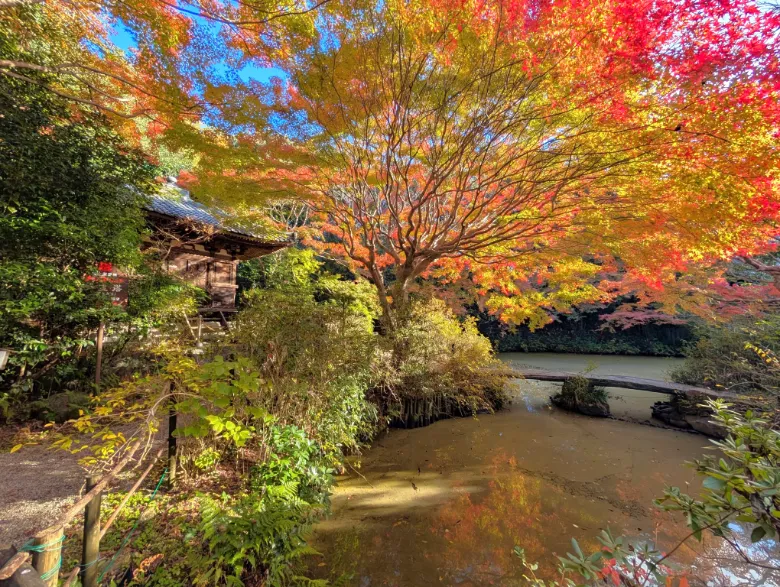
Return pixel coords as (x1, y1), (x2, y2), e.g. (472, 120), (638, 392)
(178, 0), (780, 328)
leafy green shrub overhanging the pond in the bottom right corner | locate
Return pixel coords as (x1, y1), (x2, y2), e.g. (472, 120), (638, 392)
(515, 401), (780, 587)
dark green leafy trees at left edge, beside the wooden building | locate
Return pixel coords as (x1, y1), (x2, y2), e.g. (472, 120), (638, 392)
(0, 21), (204, 420)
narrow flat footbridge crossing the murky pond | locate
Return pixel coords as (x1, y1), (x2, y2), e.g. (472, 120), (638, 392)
(510, 369), (740, 401)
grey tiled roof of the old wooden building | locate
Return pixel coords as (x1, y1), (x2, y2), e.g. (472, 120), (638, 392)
(146, 184), (289, 243)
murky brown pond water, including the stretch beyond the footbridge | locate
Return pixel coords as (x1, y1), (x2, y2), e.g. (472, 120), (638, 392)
(313, 353), (780, 587)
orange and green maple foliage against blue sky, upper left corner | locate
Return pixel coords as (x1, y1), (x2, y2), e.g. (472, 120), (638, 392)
(0, 0), (329, 149)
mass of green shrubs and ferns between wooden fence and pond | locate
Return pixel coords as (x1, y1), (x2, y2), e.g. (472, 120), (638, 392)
(59, 250), (377, 585)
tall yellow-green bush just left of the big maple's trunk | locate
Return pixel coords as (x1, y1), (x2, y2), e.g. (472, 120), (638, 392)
(234, 249), (377, 464)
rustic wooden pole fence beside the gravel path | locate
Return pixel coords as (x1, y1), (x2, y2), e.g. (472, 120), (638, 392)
(0, 406), (176, 587)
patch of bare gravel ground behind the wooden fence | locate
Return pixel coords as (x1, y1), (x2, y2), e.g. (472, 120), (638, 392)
(0, 446), (85, 547)
